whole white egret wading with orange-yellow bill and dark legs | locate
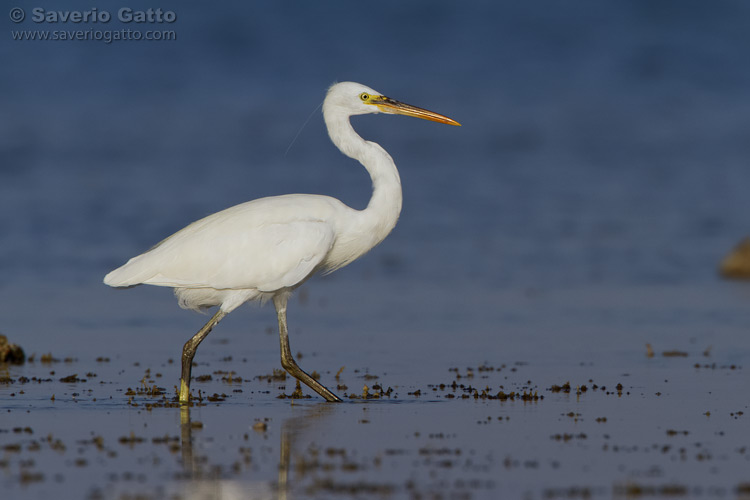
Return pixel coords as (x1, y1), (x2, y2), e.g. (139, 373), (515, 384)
(104, 82), (460, 403)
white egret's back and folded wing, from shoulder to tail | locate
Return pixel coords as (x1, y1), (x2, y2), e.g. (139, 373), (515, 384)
(104, 194), (351, 291)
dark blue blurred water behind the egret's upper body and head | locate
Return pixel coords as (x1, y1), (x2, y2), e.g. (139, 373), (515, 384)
(0, 0), (750, 292)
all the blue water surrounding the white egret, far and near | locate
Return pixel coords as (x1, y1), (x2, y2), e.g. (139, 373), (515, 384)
(0, 0), (750, 499)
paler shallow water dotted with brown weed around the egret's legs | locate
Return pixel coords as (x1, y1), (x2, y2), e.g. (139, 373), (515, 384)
(0, 280), (750, 498)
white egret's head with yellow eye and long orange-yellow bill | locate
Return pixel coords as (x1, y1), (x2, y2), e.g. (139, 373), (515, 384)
(323, 82), (461, 126)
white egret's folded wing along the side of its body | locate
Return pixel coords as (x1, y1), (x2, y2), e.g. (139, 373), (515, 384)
(108, 220), (335, 292)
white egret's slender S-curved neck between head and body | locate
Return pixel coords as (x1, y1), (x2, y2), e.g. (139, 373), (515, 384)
(325, 115), (403, 244)
